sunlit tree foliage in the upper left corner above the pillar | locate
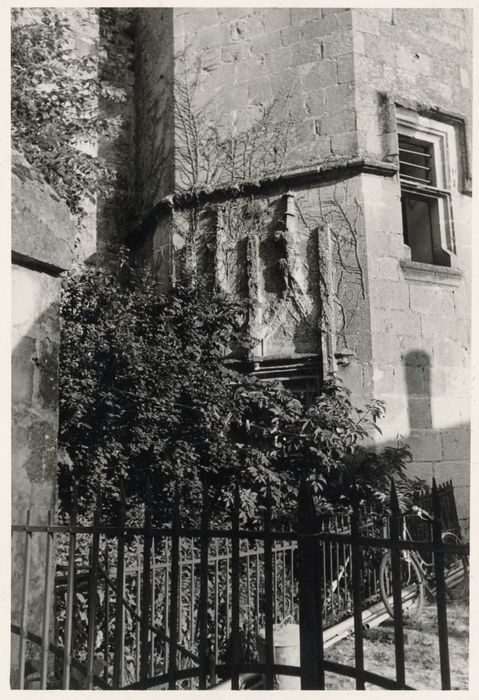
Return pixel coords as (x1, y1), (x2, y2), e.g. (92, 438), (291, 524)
(11, 8), (125, 218)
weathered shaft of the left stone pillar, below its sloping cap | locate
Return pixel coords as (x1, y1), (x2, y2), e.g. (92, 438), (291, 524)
(11, 264), (60, 685)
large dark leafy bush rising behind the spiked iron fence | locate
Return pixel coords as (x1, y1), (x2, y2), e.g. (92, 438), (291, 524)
(60, 256), (424, 521)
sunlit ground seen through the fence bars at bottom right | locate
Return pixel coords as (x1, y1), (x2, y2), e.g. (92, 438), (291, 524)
(325, 602), (469, 690)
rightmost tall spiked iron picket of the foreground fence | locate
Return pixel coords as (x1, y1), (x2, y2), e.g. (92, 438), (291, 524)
(432, 479), (451, 690)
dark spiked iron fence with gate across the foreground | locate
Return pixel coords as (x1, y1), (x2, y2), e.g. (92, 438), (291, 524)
(11, 482), (468, 690)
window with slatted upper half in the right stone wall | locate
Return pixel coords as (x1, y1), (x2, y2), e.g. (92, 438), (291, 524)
(398, 110), (457, 267)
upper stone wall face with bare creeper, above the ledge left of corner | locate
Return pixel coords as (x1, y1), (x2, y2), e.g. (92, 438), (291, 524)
(133, 8), (366, 197)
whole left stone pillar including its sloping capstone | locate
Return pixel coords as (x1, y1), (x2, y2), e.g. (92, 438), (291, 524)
(11, 153), (80, 687)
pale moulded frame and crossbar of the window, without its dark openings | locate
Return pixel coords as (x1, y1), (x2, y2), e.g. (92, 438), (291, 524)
(396, 106), (460, 267)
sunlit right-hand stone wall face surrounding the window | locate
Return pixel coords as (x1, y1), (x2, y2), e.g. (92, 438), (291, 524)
(353, 8), (472, 529)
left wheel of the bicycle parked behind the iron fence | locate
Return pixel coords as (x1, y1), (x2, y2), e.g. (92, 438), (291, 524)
(379, 552), (424, 618)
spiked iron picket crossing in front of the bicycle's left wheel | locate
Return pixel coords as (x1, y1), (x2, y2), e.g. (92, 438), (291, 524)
(389, 480), (406, 689)
